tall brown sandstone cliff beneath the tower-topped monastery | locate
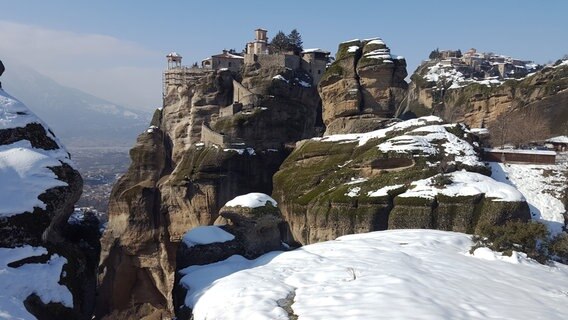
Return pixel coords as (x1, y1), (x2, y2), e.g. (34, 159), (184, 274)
(97, 68), (319, 319)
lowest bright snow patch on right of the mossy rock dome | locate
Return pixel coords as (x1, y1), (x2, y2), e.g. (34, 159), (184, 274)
(399, 170), (524, 202)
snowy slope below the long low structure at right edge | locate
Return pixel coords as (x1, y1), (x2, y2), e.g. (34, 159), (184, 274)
(490, 162), (568, 235)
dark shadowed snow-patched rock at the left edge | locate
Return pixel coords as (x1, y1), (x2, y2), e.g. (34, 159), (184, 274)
(0, 89), (99, 319)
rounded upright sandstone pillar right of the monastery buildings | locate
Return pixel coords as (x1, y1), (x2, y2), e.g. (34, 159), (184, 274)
(318, 39), (407, 134)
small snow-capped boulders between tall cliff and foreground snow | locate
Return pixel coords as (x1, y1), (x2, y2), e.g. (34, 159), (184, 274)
(173, 193), (286, 320)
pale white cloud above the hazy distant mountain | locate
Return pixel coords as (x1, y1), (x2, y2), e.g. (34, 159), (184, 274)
(0, 20), (163, 109)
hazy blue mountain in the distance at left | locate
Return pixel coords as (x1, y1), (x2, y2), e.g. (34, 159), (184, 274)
(2, 63), (150, 148)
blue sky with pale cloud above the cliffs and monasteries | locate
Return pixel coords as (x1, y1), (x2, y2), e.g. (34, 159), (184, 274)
(0, 0), (568, 109)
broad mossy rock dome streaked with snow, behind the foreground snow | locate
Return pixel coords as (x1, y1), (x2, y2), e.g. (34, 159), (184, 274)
(273, 117), (530, 244)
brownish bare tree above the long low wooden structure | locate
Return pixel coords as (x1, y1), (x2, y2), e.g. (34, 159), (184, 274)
(489, 108), (550, 147)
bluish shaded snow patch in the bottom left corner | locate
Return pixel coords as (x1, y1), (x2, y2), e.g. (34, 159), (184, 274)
(0, 246), (73, 320)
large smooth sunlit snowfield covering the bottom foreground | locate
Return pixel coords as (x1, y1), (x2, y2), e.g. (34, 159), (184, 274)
(182, 230), (568, 320)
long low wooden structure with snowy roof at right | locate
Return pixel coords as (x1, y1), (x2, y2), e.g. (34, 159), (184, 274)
(483, 149), (556, 164)
